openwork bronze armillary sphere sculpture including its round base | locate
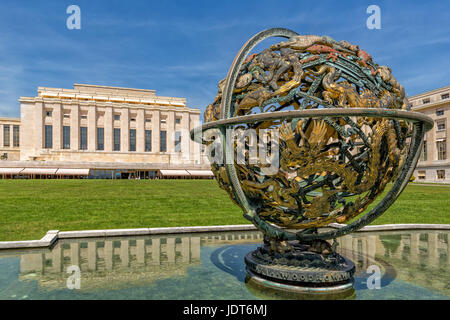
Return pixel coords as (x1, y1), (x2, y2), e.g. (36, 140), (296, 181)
(191, 28), (433, 292)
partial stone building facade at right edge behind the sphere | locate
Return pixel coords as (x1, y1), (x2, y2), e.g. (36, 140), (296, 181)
(408, 86), (450, 183)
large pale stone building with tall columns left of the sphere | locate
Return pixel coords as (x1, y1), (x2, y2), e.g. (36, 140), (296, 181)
(0, 84), (209, 178)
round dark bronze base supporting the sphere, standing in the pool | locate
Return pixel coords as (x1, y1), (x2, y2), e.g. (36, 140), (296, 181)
(245, 243), (355, 299)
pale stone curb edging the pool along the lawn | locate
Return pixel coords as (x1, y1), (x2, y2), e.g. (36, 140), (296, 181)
(0, 223), (450, 250)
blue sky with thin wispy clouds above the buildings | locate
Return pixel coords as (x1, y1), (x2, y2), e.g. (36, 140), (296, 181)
(0, 0), (450, 117)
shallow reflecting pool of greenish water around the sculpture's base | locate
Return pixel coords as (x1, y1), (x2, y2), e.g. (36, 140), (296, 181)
(0, 230), (450, 300)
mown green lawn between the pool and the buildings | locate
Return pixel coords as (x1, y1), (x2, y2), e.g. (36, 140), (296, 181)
(0, 180), (450, 240)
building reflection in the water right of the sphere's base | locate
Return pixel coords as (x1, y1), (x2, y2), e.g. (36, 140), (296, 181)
(338, 231), (450, 296)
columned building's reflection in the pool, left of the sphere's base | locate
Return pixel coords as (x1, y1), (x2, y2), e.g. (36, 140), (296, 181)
(14, 231), (262, 290)
